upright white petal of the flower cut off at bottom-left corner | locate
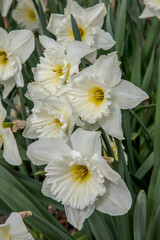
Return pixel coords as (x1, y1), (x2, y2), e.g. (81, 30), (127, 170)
(6, 212), (34, 240)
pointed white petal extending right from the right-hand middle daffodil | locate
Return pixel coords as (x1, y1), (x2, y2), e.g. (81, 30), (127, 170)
(112, 80), (149, 109)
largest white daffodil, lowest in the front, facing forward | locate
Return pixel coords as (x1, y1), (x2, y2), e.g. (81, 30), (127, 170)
(27, 129), (132, 229)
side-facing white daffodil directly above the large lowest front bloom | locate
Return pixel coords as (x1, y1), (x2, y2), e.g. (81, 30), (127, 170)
(23, 92), (81, 139)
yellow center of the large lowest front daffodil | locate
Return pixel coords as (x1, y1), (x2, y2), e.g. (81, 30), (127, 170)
(71, 164), (91, 183)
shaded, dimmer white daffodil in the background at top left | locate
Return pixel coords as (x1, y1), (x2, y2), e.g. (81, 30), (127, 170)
(12, 0), (42, 31)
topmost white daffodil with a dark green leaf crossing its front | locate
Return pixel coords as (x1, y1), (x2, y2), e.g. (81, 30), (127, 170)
(47, 0), (115, 50)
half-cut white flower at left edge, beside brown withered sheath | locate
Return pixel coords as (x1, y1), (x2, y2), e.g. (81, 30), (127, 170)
(0, 100), (22, 165)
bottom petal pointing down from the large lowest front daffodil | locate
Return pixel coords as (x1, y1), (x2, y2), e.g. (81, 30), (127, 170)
(65, 205), (94, 230)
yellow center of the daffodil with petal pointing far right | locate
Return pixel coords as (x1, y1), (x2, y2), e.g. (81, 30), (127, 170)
(89, 87), (104, 106)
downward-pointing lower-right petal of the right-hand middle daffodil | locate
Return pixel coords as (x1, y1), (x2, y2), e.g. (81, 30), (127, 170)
(98, 103), (124, 140)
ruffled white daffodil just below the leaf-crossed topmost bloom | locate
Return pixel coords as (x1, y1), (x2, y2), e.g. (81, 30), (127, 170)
(33, 36), (95, 95)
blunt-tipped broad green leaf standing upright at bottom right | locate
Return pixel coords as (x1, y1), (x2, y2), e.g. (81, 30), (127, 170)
(134, 190), (147, 240)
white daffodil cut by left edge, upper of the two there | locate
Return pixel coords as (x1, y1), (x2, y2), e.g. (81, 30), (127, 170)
(0, 28), (34, 98)
